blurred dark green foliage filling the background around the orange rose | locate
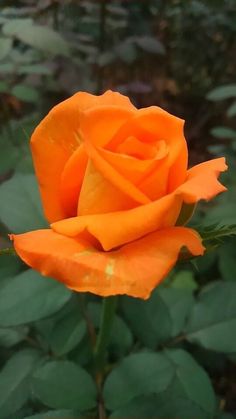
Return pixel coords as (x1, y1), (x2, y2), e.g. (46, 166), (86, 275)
(0, 0), (236, 419)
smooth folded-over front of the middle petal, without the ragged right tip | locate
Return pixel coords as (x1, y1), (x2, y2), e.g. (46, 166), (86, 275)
(51, 195), (182, 250)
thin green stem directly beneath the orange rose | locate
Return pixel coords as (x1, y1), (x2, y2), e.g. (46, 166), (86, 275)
(94, 297), (117, 371)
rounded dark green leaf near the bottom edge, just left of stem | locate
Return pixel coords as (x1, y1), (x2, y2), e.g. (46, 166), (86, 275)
(33, 361), (96, 411)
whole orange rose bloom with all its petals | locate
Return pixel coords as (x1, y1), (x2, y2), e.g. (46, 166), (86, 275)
(12, 91), (227, 299)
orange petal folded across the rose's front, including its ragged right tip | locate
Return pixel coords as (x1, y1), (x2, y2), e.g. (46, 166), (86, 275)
(52, 158), (227, 250)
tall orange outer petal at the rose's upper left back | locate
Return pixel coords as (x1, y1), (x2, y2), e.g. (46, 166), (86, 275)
(31, 91), (136, 222)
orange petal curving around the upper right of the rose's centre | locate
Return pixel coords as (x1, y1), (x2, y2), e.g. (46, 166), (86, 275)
(107, 106), (188, 195)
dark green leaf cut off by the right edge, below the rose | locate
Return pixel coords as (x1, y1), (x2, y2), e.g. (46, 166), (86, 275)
(186, 281), (236, 353)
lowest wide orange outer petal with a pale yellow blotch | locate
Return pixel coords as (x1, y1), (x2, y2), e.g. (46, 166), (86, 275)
(12, 227), (204, 299)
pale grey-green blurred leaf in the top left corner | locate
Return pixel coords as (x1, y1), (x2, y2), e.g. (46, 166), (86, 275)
(2, 19), (70, 56)
